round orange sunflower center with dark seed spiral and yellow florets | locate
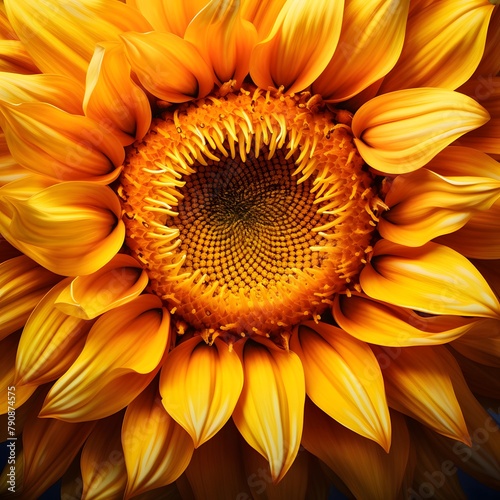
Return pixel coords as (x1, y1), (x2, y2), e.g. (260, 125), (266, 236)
(118, 88), (381, 335)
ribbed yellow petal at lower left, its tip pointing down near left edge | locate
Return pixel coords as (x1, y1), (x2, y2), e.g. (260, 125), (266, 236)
(16, 278), (92, 385)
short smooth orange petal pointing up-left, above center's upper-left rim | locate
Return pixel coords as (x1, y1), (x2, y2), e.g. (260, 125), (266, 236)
(122, 32), (215, 102)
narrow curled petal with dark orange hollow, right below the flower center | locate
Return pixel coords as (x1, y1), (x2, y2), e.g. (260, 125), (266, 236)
(333, 295), (486, 347)
